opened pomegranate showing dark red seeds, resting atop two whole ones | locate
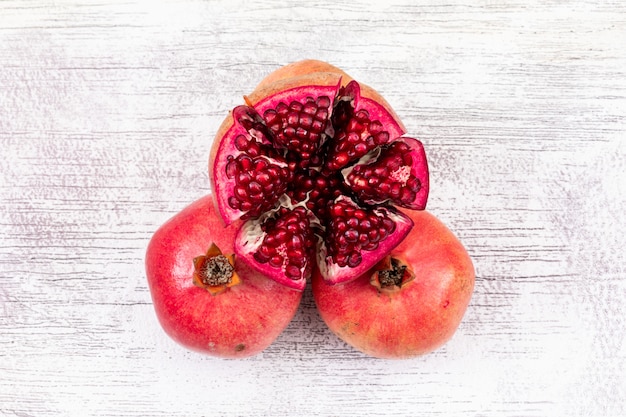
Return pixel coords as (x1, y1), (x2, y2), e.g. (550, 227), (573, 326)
(209, 61), (428, 289)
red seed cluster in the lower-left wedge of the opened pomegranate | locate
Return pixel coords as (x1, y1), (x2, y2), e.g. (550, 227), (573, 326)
(253, 207), (315, 279)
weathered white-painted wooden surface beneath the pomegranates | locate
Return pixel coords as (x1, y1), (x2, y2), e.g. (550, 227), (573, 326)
(0, 0), (626, 417)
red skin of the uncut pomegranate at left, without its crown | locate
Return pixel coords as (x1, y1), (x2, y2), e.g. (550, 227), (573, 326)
(146, 195), (302, 358)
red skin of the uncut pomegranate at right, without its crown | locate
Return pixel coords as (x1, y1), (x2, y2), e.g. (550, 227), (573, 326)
(313, 210), (475, 359)
